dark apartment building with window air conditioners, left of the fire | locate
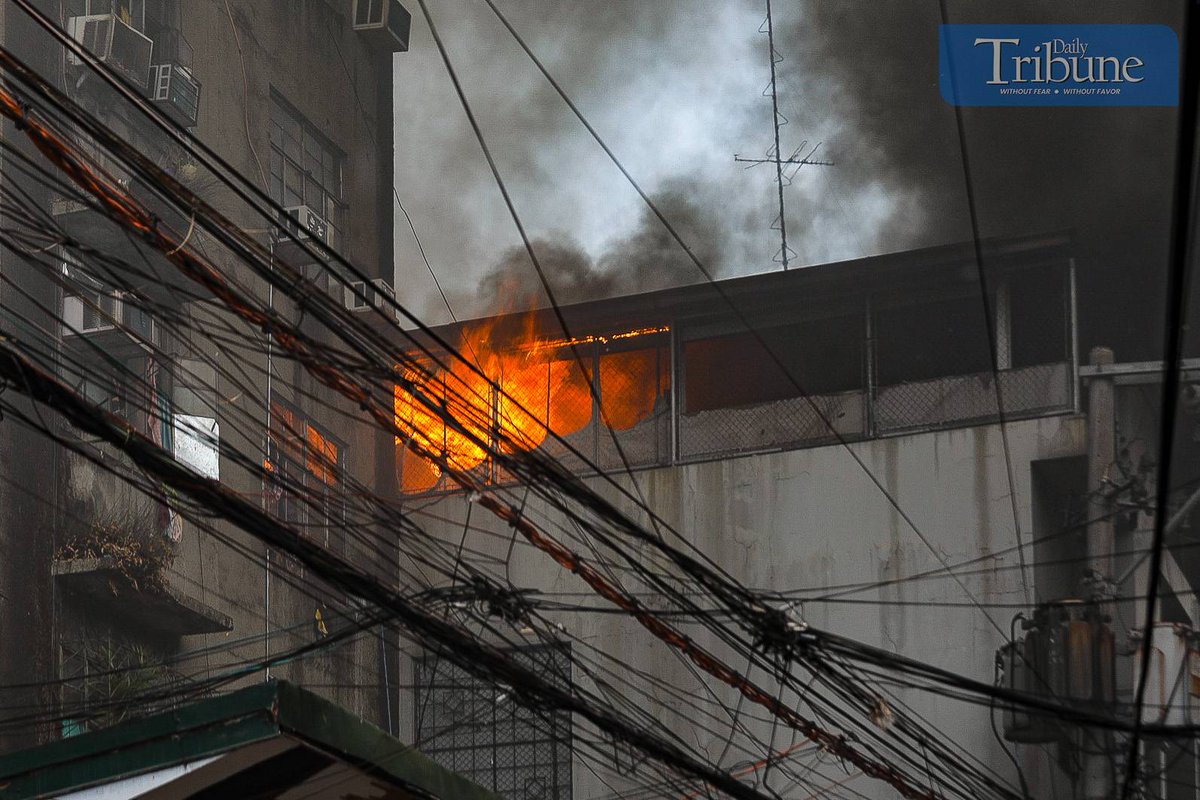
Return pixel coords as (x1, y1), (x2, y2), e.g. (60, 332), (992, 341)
(0, 0), (409, 748)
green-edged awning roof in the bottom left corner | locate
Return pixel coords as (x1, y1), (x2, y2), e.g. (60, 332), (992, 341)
(0, 681), (499, 800)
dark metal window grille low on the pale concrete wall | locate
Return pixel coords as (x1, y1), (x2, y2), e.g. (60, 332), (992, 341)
(414, 645), (572, 800)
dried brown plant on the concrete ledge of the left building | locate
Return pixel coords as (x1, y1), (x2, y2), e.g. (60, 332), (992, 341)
(54, 506), (175, 594)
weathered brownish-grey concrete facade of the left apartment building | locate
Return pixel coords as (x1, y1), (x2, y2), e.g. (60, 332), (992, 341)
(0, 0), (403, 746)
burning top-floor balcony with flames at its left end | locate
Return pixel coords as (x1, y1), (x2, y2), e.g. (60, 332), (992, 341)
(395, 231), (1076, 494)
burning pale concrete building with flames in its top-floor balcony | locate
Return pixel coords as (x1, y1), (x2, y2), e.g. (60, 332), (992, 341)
(384, 235), (1087, 798)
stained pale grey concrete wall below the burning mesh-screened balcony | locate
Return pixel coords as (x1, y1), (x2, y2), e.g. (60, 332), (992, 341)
(401, 416), (1086, 798)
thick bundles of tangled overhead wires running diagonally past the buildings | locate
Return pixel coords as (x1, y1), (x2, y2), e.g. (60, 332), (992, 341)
(0, 0), (1190, 798)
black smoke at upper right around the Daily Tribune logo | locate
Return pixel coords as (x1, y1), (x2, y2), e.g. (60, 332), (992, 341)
(780, 0), (1182, 360)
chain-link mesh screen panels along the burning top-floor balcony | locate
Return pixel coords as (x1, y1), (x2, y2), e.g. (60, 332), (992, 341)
(397, 263), (1075, 493)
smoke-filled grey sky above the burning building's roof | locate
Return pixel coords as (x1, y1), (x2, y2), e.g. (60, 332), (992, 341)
(395, 0), (1178, 357)
